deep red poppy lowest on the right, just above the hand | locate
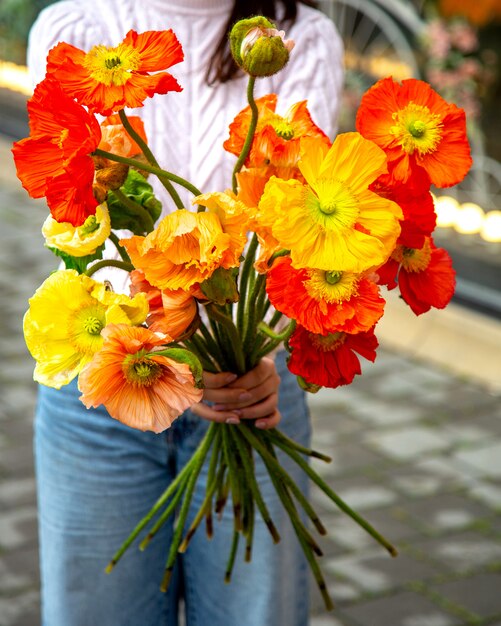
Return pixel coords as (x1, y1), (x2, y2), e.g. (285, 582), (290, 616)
(287, 326), (378, 388)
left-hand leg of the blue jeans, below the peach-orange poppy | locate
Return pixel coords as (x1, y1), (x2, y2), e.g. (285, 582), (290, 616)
(35, 384), (177, 626)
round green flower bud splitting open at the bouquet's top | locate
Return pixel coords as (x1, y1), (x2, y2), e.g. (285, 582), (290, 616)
(230, 16), (294, 77)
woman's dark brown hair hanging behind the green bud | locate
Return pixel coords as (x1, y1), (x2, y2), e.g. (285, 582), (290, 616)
(206, 0), (315, 85)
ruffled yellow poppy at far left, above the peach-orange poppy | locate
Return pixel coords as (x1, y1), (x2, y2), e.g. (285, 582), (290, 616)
(24, 270), (148, 389)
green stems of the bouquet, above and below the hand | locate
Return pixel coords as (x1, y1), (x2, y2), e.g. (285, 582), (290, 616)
(96, 77), (397, 610)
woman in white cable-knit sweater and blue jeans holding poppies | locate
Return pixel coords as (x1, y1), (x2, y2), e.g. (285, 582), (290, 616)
(29, 0), (342, 626)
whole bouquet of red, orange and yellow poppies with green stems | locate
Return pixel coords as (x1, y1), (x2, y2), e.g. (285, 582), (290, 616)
(13, 17), (471, 608)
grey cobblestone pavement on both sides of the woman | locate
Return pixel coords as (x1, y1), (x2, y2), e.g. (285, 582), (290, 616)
(0, 133), (501, 626)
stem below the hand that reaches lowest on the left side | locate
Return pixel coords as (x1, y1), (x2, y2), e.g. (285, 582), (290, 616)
(160, 422), (217, 592)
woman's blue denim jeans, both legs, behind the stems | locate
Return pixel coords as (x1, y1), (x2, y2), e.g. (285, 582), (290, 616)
(35, 355), (310, 626)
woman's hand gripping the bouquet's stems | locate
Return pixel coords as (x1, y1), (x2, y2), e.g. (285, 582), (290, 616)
(191, 357), (282, 430)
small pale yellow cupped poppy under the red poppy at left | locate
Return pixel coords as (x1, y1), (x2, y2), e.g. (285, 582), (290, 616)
(42, 203), (111, 257)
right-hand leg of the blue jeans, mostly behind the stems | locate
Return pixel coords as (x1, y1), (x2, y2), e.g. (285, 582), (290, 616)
(178, 355), (310, 626)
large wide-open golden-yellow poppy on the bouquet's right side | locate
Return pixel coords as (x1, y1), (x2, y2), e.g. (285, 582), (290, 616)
(258, 133), (402, 273)
